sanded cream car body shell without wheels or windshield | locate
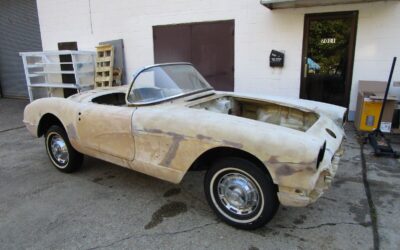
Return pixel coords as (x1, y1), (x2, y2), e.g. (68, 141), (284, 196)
(24, 72), (346, 206)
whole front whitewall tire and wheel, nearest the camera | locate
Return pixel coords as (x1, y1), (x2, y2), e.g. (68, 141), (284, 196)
(204, 157), (279, 229)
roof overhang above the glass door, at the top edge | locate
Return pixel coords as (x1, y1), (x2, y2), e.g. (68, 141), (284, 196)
(260, 0), (399, 10)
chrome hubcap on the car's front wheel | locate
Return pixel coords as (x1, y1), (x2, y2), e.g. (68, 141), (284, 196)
(217, 173), (260, 215)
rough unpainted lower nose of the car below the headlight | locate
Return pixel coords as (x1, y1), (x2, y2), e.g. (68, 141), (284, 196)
(278, 145), (344, 207)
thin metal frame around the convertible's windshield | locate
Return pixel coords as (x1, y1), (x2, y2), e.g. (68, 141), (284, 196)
(125, 62), (214, 106)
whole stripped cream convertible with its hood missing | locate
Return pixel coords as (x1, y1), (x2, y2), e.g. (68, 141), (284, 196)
(24, 63), (346, 229)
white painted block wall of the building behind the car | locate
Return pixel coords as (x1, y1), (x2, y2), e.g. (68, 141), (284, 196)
(37, 0), (400, 115)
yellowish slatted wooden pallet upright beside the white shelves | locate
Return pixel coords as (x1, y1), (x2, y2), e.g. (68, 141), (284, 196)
(95, 44), (114, 88)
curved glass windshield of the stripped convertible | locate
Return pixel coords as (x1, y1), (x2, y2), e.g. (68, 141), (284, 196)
(127, 64), (212, 104)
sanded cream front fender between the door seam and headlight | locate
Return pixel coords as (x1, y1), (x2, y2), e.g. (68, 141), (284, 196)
(133, 105), (324, 188)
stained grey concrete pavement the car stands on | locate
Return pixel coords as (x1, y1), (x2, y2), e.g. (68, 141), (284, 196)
(0, 99), (400, 250)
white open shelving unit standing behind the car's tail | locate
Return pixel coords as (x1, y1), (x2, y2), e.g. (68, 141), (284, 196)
(19, 50), (96, 101)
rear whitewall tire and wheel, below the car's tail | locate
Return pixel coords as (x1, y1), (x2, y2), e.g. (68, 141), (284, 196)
(45, 125), (83, 173)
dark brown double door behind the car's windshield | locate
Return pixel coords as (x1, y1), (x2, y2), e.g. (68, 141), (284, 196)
(153, 20), (235, 91)
